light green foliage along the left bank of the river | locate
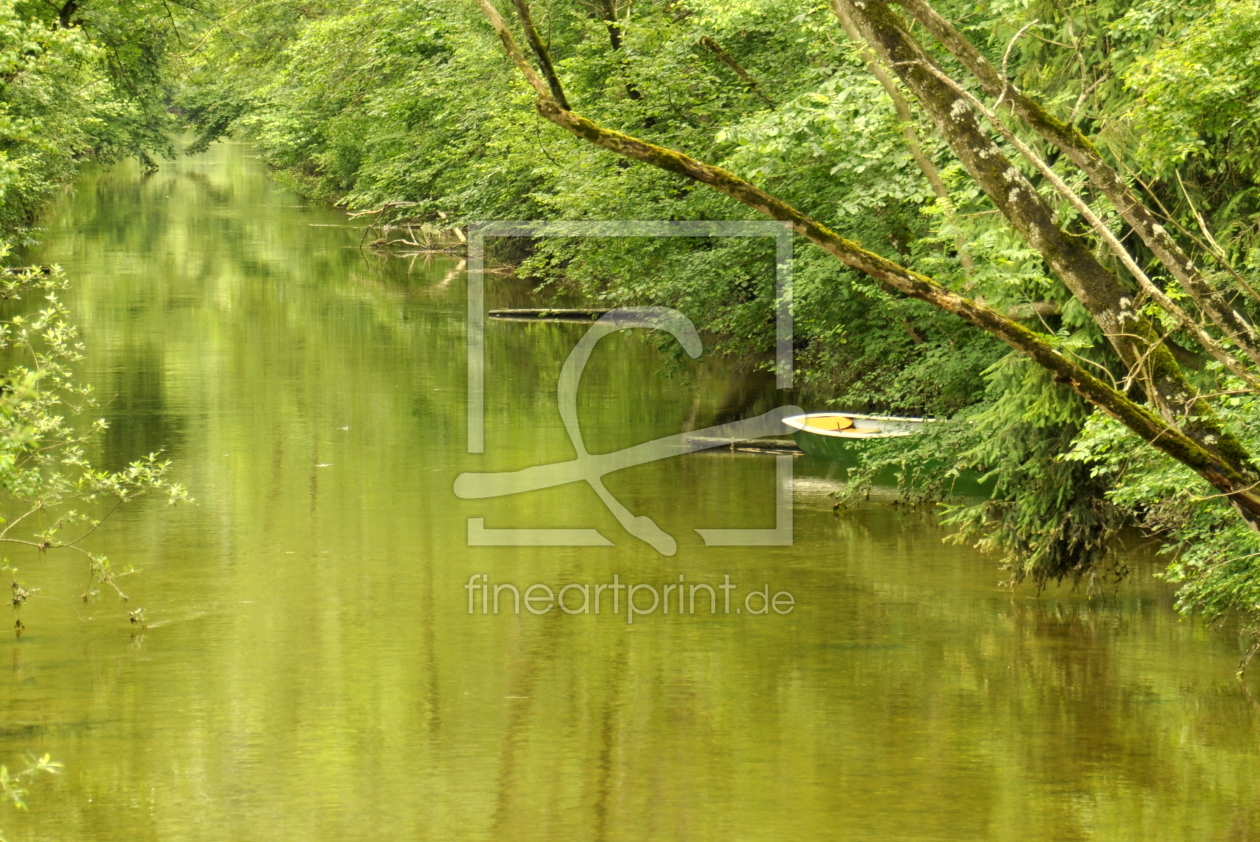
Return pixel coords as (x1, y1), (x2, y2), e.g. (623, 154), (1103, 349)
(0, 0), (191, 637)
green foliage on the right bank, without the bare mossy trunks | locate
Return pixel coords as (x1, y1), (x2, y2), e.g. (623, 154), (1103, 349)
(175, 0), (1260, 640)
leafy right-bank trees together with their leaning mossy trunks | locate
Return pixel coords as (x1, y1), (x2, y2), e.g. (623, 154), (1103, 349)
(180, 0), (1260, 655)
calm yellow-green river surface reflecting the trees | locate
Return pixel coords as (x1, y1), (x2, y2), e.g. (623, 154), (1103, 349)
(0, 145), (1260, 842)
